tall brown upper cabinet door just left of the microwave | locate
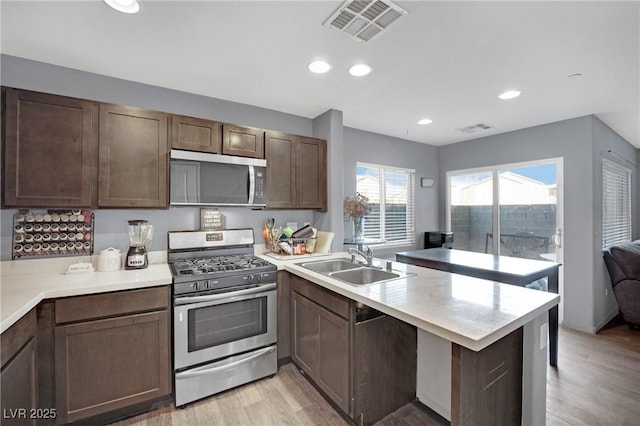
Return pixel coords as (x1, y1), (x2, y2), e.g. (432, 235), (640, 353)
(98, 104), (169, 208)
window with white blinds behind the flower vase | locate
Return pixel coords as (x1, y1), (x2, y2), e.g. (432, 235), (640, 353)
(356, 163), (415, 244)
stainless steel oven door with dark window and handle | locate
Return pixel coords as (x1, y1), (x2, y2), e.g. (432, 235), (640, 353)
(173, 283), (277, 370)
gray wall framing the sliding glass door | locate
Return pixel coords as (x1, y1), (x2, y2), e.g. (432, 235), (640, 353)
(439, 116), (638, 332)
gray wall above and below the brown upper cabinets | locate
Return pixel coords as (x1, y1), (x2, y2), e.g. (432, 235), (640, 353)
(0, 55), (318, 260)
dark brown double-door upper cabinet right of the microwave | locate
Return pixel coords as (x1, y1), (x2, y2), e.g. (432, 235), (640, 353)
(265, 131), (327, 210)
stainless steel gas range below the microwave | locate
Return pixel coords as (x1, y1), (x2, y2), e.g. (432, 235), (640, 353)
(168, 229), (278, 407)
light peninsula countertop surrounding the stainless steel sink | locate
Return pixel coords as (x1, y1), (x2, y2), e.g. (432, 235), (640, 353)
(265, 253), (560, 351)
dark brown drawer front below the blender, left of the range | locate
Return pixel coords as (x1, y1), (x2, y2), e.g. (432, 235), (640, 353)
(55, 286), (169, 324)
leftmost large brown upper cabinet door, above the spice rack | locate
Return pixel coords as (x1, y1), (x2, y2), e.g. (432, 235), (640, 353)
(3, 89), (95, 207)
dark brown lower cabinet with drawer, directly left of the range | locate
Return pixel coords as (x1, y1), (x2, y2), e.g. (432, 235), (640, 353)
(54, 287), (172, 424)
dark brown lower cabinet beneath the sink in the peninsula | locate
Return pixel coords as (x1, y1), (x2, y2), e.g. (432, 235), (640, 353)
(290, 276), (417, 424)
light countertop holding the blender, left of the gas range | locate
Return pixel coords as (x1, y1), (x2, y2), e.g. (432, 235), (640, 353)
(0, 256), (172, 333)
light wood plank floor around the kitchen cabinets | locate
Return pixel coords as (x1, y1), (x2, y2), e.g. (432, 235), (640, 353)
(113, 318), (640, 426)
